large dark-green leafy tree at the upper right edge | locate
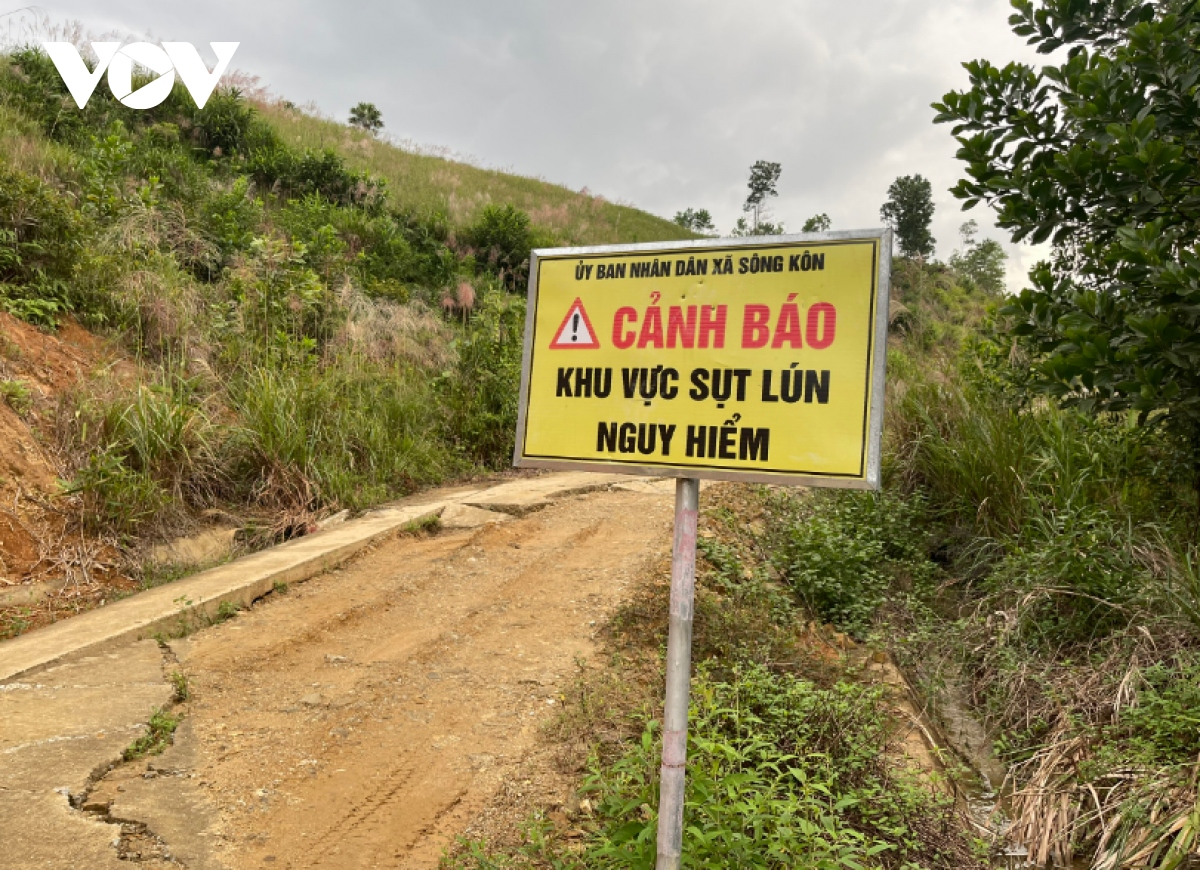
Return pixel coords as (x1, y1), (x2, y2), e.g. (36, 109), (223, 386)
(934, 0), (1200, 508)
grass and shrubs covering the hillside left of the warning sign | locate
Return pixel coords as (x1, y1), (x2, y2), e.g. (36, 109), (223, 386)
(0, 42), (688, 548)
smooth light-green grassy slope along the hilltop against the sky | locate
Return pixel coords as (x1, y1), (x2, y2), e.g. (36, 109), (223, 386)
(259, 103), (700, 245)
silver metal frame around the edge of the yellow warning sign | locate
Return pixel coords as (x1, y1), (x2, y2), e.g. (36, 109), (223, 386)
(512, 229), (892, 490)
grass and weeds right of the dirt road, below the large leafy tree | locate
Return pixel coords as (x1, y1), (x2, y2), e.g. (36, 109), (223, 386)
(446, 234), (1200, 868)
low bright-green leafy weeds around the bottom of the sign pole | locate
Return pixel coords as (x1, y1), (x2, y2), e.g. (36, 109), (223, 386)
(584, 666), (979, 870)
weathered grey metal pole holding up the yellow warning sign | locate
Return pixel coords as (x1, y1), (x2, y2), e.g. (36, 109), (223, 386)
(656, 478), (700, 870)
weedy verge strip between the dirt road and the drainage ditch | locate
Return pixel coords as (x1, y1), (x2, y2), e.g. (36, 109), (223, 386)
(444, 485), (985, 870)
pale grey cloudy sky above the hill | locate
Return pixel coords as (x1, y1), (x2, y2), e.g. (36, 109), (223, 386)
(16, 0), (1051, 289)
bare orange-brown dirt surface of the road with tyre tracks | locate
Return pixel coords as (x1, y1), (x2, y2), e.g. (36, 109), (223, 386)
(106, 481), (672, 869)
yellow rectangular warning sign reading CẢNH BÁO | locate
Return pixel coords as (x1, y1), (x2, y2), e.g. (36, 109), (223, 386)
(515, 230), (892, 488)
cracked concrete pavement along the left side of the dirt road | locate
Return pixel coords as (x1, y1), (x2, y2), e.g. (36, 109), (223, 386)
(0, 474), (673, 870)
